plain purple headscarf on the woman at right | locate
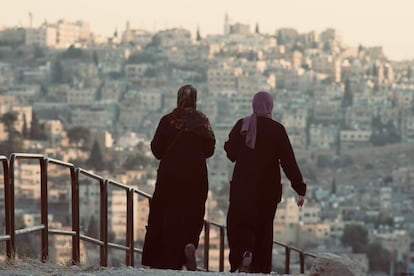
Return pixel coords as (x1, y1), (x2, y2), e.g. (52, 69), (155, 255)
(241, 91), (273, 149)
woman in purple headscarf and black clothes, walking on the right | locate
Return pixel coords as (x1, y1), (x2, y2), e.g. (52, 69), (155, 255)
(224, 91), (306, 273)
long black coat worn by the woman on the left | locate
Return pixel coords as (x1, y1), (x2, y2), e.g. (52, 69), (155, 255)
(142, 113), (215, 269)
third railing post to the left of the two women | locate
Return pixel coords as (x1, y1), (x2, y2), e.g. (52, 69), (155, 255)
(70, 168), (80, 264)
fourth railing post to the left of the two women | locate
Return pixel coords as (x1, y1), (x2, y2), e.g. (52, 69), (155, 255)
(39, 158), (49, 262)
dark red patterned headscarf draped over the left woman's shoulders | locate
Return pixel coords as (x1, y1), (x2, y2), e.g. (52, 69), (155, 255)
(168, 84), (214, 139)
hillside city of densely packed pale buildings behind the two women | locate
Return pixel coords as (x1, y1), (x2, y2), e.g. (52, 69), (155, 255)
(0, 15), (414, 275)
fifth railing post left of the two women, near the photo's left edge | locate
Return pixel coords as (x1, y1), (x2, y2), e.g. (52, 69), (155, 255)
(7, 154), (16, 260)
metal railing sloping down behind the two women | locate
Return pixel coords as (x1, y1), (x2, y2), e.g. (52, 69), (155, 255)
(0, 153), (316, 273)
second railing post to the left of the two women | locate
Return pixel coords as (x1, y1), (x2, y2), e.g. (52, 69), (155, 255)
(99, 180), (108, 267)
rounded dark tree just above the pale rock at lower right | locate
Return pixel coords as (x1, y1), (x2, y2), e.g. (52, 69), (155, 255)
(341, 223), (368, 253)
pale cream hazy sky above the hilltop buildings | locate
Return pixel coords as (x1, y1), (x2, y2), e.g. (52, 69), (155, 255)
(0, 0), (414, 59)
